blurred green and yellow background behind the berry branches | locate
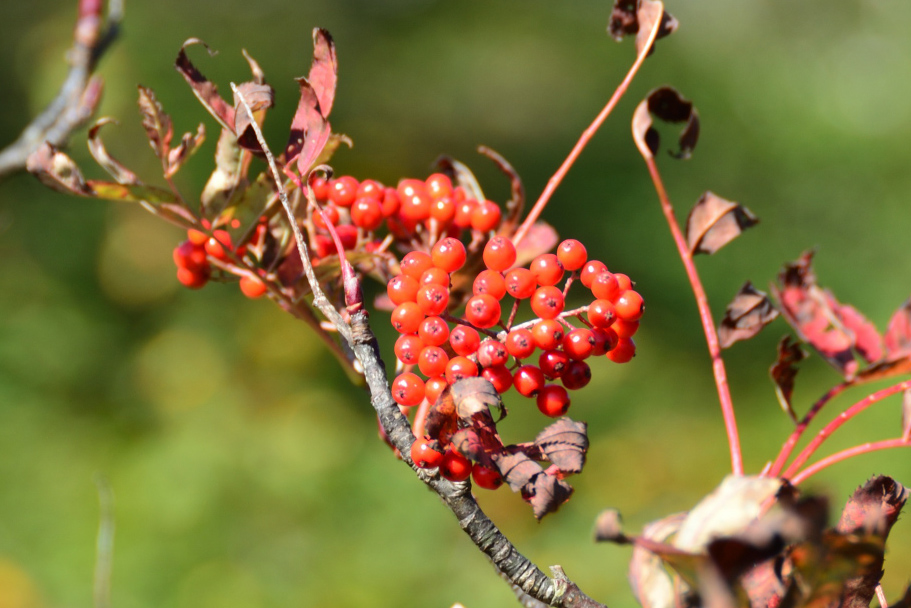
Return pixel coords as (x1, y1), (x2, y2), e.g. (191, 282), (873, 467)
(0, 0), (911, 608)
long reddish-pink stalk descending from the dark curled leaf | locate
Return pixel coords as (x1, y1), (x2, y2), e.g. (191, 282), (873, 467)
(642, 154), (743, 475)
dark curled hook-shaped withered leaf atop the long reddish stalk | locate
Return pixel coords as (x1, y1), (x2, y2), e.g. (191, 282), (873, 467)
(633, 87), (699, 159)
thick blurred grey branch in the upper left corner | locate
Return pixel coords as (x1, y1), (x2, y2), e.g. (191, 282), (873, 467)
(0, 0), (123, 179)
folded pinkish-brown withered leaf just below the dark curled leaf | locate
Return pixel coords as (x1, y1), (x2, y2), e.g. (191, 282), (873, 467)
(686, 192), (759, 255)
